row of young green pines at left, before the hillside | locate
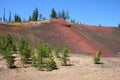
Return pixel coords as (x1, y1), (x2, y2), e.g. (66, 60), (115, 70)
(0, 34), (70, 71)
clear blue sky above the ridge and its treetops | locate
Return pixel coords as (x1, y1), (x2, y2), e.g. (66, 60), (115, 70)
(0, 0), (120, 26)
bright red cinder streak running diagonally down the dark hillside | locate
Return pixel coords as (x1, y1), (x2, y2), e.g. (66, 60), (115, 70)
(51, 19), (115, 57)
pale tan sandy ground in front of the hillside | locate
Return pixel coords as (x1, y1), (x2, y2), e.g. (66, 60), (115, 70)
(0, 54), (120, 80)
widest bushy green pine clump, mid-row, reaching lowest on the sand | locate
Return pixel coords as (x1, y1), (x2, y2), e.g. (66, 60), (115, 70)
(37, 41), (56, 70)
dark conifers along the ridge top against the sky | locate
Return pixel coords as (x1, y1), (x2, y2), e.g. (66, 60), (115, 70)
(0, 8), (77, 22)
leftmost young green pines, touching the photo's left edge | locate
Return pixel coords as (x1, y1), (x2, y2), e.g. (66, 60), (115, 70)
(0, 34), (15, 68)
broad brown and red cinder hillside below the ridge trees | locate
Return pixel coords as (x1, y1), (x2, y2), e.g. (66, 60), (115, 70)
(0, 19), (120, 57)
